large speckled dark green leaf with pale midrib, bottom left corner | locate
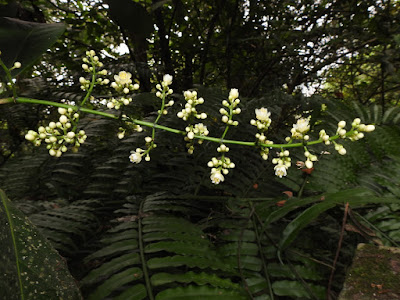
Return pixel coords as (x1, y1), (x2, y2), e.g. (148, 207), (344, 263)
(0, 190), (81, 300)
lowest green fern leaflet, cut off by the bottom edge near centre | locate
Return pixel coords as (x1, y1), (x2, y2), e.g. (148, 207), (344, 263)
(156, 285), (247, 300)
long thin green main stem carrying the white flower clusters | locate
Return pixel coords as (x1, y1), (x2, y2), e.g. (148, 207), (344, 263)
(0, 97), (346, 149)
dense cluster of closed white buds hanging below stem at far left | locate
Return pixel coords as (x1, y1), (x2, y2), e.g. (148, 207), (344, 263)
(25, 107), (87, 157)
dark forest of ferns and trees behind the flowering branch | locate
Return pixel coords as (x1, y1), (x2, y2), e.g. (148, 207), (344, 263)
(0, 0), (400, 299)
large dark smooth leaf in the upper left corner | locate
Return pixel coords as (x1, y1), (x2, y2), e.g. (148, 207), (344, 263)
(0, 17), (65, 77)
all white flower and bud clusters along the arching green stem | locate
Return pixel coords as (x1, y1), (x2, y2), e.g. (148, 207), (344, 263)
(18, 50), (375, 184)
